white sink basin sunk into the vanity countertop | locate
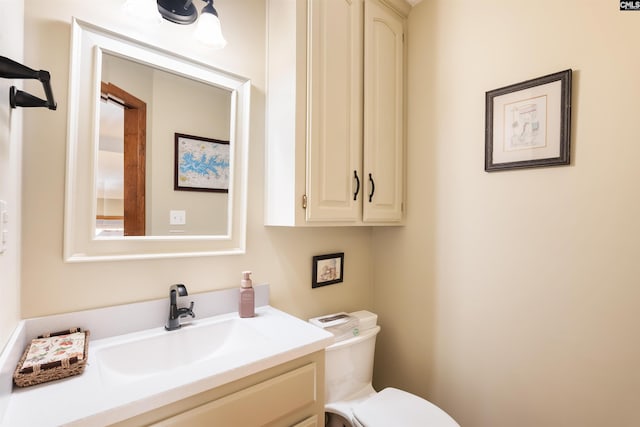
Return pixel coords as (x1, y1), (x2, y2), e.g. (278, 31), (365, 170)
(96, 318), (267, 383)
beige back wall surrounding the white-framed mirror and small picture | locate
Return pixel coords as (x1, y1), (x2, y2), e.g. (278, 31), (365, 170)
(22, 0), (373, 318)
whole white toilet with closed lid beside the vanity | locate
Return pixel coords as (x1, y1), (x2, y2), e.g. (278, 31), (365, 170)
(310, 310), (460, 427)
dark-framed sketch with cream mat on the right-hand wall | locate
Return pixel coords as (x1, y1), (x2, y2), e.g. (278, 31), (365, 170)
(485, 69), (571, 172)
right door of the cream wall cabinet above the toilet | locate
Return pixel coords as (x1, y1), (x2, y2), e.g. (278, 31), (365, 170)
(363, 0), (404, 222)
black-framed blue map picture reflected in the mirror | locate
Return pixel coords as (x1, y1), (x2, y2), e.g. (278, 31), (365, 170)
(173, 133), (230, 193)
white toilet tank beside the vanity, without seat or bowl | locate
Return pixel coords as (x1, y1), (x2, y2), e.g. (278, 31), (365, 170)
(325, 311), (380, 403)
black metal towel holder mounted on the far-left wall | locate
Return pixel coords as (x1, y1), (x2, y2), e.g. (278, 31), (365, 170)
(0, 56), (57, 110)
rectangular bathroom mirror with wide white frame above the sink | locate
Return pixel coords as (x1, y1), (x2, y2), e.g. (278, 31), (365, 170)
(64, 19), (250, 262)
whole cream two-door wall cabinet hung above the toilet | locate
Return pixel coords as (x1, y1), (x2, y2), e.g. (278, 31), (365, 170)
(265, 0), (405, 226)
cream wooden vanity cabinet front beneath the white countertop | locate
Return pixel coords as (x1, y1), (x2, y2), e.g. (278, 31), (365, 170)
(109, 351), (324, 427)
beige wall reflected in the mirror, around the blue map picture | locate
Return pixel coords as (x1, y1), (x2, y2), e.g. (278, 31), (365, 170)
(148, 72), (231, 236)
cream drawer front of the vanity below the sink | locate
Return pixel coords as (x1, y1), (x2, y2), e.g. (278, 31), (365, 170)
(153, 362), (317, 427)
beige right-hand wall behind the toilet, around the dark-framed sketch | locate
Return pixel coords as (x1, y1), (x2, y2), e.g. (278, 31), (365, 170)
(373, 0), (640, 427)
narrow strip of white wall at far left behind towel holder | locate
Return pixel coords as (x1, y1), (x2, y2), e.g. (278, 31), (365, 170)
(0, 0), (23, 351)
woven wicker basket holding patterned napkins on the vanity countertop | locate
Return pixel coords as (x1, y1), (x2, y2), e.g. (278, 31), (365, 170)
(13, 328), (89, 387)
